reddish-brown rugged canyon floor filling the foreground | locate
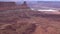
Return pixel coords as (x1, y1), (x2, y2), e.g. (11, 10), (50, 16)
(0, 9), (60, 34)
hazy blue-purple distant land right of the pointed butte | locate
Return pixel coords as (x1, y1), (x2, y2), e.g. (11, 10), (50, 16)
(27, 1), (60, 8)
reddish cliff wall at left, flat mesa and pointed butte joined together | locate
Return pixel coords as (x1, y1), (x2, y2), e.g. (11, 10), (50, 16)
(0, 2), (29, 10)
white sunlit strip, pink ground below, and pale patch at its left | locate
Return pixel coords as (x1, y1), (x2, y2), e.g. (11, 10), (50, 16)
(31, 8), (60, 14)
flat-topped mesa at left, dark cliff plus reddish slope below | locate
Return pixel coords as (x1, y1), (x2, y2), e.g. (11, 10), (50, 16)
(0, 2), (16, 10)
